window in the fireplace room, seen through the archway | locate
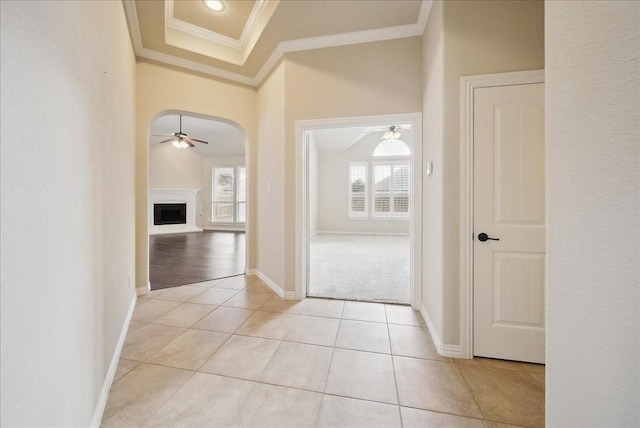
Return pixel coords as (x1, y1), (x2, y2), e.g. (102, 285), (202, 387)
(211, 166), (247, 224)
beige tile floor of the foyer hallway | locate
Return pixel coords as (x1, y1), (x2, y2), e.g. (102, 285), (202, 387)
(102, 276), (544, 428)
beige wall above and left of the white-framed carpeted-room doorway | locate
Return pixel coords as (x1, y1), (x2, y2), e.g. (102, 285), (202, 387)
(282, 37), (422, 292)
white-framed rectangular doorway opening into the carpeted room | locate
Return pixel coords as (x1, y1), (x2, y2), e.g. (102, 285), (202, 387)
(296, 114), (421, 304)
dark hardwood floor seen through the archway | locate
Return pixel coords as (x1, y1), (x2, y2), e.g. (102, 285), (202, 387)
(149, 231), (245, 290)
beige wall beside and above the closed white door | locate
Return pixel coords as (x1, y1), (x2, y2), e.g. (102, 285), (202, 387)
(422, 1), (544, 345)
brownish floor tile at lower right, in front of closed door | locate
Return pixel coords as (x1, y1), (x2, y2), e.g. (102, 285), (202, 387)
(458, 364), (544, 426)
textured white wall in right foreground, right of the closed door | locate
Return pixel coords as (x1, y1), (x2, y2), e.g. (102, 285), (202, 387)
(545, 1), (640, 427)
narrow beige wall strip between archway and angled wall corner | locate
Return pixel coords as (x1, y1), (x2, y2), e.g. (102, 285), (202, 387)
(256, 62), (286, 289)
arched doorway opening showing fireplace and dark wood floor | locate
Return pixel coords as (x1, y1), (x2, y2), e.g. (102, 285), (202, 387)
(149, 111), (248, 289)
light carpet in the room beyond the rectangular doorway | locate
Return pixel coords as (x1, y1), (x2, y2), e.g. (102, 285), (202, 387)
(308, 233), (410, 303)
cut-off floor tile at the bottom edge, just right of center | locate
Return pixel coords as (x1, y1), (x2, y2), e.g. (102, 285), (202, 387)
(316, 395), (402, 428)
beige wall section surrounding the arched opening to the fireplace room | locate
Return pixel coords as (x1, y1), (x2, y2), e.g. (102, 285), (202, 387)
(136, 62), (256, 291)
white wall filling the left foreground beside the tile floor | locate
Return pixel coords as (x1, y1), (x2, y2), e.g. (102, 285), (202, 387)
(0, 1), (135, 427)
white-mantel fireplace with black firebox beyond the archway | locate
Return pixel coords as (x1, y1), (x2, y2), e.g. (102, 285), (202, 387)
(149, 187), (202, 235)
